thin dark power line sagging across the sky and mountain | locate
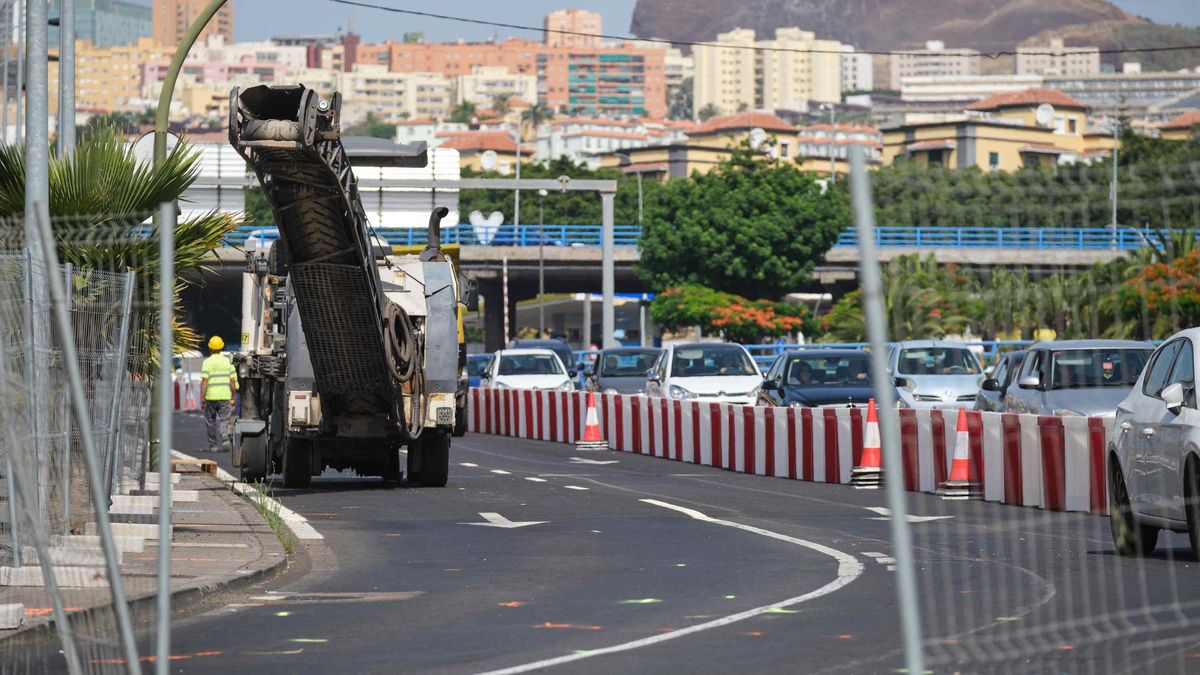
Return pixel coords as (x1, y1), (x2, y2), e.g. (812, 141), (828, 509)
(328, 0), (1200, 59)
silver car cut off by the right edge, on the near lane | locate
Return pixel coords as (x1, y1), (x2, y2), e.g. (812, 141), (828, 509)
(1108, 328), (1200, 555)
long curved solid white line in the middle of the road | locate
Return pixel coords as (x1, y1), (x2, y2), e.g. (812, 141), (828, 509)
(481, 500), (863, 675)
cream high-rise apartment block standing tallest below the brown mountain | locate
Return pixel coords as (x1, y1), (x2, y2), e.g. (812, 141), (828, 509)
(692, 28), (845, 114)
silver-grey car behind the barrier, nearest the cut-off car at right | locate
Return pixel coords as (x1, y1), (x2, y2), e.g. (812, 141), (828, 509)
(1004, 340), (1154, 417)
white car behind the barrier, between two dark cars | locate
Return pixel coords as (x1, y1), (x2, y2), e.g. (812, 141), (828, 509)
(646, 342), (762, 406)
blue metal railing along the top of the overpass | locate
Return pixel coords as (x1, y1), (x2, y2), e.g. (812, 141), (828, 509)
(226, 225), (1171, 251)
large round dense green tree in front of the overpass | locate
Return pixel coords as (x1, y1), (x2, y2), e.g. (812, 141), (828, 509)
(637, 145), (850, 298)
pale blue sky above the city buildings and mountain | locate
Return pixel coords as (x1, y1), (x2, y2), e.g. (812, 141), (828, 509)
(232, 0), (1200, 42)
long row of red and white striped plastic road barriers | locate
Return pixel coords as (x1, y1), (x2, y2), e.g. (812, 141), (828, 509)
(469, 389), (1111, 513)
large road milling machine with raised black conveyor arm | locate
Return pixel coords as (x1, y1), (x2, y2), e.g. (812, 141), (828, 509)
(229, 85), (475, 488)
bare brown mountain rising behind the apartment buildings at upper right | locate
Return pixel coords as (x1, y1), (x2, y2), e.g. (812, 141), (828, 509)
(630, 0), (1200, 67)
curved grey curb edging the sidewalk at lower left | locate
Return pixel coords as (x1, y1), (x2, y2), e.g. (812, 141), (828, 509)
(0, 466), (288, 644)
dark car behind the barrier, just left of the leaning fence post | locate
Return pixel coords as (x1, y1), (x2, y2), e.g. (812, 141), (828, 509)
(758, 350), (897, 407)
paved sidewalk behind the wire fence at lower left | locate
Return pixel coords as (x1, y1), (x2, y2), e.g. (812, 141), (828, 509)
(0, 458), (287, 643)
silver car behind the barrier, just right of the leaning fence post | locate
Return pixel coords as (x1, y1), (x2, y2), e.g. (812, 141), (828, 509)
(888, 340), (983, 408)
